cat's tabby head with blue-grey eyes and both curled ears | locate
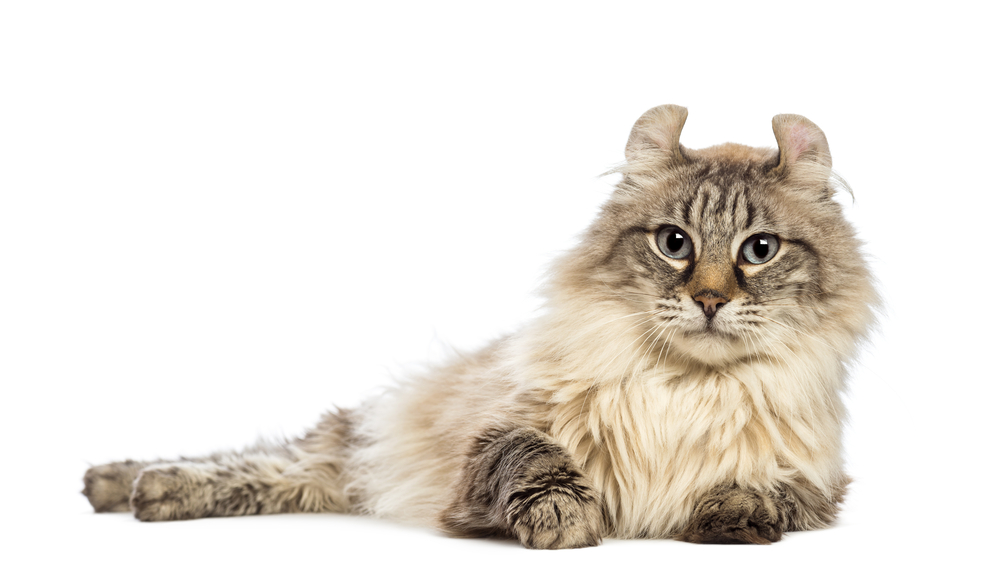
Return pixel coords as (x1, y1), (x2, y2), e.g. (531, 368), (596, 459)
(552, 105), (875, 366)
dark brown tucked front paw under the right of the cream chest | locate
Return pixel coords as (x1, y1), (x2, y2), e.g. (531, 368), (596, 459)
(678, 486), (787, 544)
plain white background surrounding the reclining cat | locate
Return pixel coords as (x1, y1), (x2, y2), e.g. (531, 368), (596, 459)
(0, 0), (1000, 576)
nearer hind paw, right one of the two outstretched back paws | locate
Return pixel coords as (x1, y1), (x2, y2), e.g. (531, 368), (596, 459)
(130, 465), (204, 522)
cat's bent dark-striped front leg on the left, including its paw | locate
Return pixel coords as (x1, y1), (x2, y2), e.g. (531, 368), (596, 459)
(441, 427), (604, 549)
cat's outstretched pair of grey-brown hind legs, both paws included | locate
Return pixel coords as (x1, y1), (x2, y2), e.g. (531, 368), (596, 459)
(83, 410), (354, 521)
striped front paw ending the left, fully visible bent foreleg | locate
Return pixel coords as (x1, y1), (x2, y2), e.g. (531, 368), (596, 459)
(508, 486), (604, 550)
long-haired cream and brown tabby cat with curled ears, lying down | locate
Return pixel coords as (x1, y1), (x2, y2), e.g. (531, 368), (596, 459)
(83, 105), (877, 549)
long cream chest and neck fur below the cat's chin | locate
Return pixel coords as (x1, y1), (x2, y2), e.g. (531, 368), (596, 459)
(509, 306), (846, 537)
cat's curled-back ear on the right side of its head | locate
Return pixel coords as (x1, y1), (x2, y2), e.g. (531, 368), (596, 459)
(771, 114), (833, 177)
